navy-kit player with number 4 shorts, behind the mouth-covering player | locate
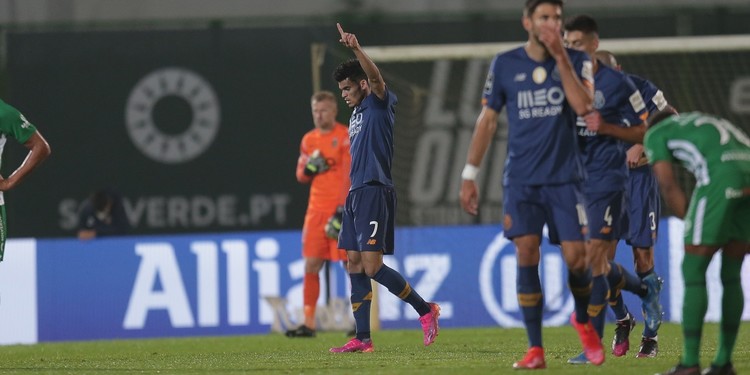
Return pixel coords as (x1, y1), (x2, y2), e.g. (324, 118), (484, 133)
(564, 15), (662, 364)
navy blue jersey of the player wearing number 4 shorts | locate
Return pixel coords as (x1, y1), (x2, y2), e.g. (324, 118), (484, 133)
(578, 64), (648, 192)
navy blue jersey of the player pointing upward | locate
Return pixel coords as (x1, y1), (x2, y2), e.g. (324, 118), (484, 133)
(349, 89), (398, 191)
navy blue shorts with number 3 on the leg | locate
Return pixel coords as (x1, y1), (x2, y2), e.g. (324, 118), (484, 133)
(622, 166), (661, 248)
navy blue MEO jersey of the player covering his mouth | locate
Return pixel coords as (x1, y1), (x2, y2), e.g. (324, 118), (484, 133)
(482, 47), (594, 186)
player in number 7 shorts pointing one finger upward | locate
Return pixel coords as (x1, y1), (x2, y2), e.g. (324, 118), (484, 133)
(330, 24), (440, 353)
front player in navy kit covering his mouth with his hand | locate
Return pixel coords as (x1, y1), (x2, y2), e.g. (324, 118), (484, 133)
(460, 0), (604, 369)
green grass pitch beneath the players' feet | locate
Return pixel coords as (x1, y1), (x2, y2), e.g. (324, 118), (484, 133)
(0, 322), (750, 375)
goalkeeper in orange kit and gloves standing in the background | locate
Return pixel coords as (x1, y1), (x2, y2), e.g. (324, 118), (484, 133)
(286, 91), (351, 337)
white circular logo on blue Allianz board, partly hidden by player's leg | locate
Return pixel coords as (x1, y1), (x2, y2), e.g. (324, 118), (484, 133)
(479, 227), (575, 327)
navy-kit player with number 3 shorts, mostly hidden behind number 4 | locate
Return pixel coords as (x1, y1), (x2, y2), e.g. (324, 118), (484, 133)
(594, 50), (671, 358)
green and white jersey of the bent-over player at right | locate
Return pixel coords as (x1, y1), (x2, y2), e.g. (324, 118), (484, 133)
(643, 112), (750, 187)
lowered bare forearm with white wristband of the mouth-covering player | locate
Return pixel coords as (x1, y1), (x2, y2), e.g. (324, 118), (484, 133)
(460, 106), (498, 215)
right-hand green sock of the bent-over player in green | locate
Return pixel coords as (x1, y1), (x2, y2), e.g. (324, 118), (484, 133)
(713, 252), (745, 366)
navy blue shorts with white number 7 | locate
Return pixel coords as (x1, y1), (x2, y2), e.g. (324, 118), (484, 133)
(339, 185), (396, 254)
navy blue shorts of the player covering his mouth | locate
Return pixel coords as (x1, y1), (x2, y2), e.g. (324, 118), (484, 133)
(503, 183), (587, 244)
